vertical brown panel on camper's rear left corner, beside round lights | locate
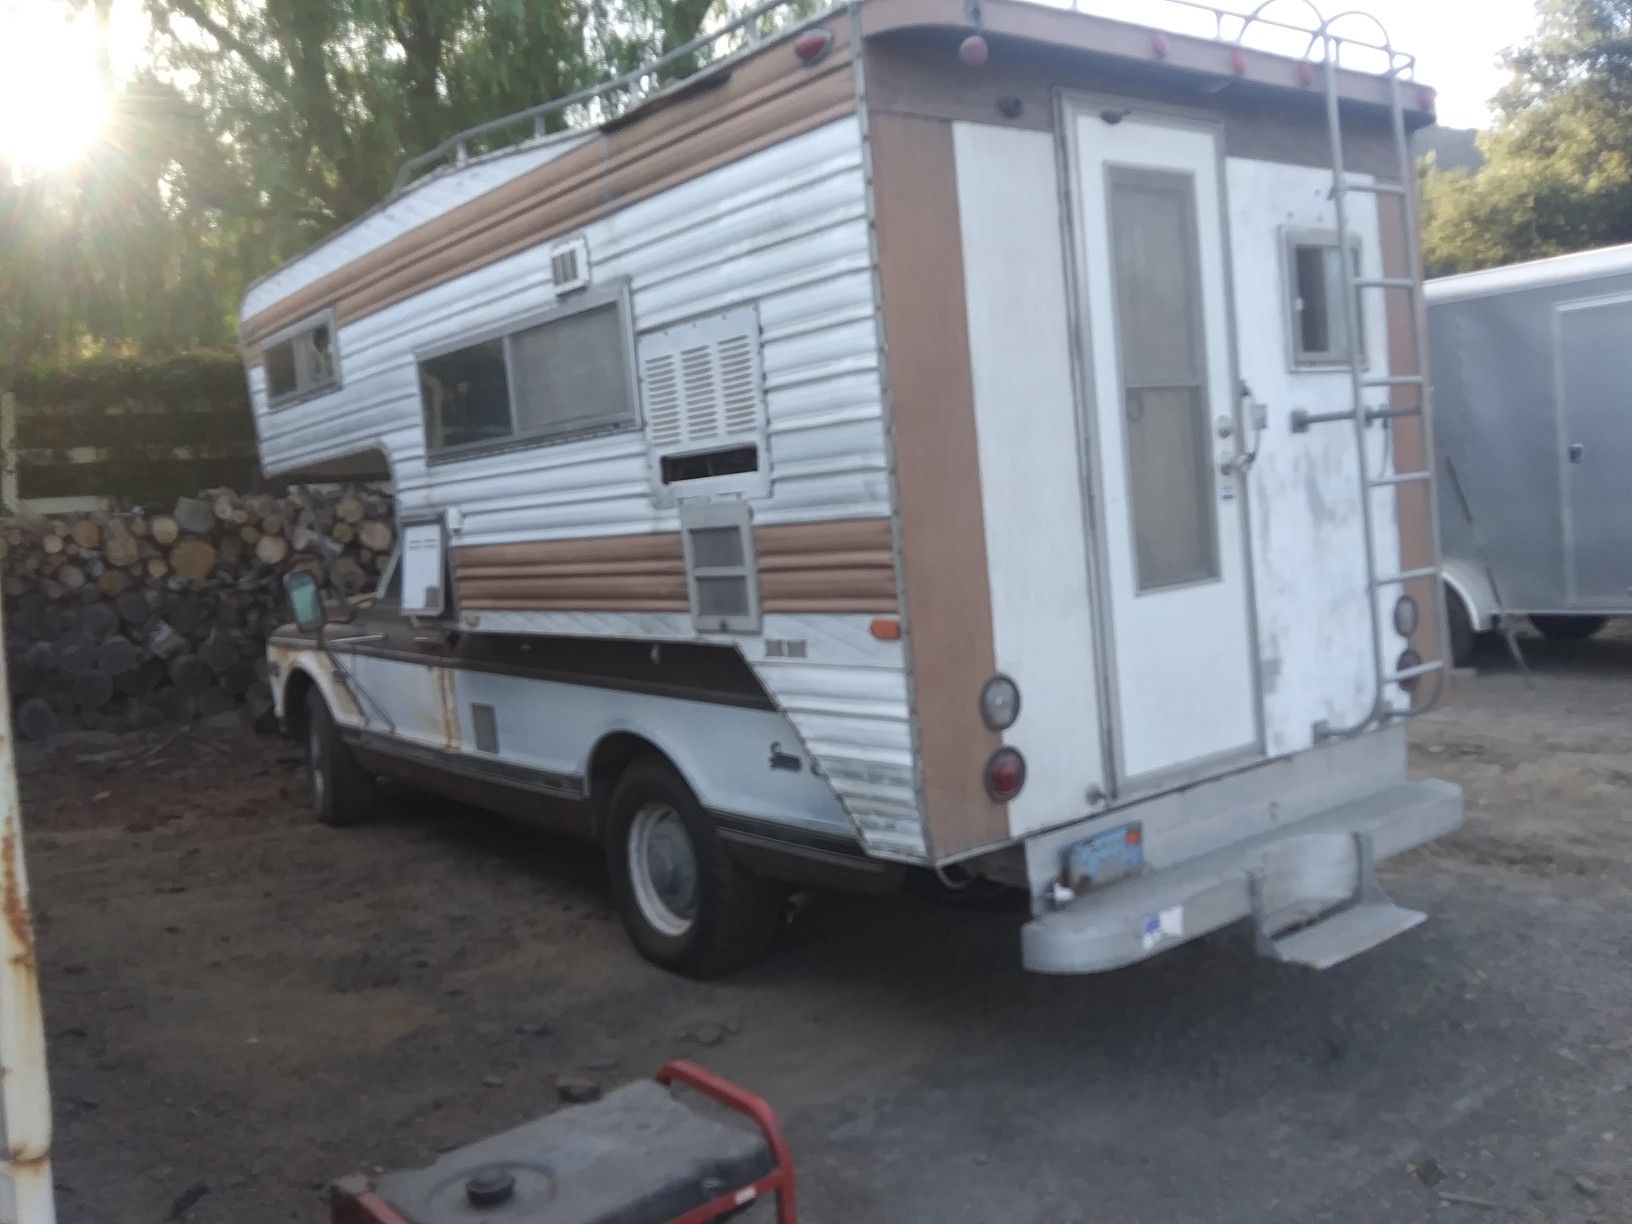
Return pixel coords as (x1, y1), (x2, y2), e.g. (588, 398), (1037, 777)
(870, 114), (1009, 858)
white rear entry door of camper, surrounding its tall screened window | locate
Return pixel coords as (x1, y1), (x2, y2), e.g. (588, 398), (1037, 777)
(1072, 108), (1262, 780)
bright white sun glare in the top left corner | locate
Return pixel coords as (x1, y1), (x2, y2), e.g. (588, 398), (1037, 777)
(0, 0), (109, 175)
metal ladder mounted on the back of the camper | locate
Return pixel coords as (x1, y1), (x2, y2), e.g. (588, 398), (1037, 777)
(1293, 21), (1449, 741)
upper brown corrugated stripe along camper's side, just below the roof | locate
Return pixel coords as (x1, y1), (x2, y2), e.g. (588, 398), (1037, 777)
(242, 18), (855, 364)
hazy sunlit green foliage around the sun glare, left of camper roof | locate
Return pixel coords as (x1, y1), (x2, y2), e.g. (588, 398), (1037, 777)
(0, 0), (744, 363)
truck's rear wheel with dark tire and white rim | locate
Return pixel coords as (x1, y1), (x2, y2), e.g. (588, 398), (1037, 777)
(605, 756), (787, 978)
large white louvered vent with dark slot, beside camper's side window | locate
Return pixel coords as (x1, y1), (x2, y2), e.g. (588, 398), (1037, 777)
(640, 307), (769, 498)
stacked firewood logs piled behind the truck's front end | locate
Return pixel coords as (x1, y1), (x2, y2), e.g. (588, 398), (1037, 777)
(0, 485), (397, 739)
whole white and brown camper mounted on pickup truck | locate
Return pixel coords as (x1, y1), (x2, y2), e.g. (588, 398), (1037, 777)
(243, 0), (1461, 973)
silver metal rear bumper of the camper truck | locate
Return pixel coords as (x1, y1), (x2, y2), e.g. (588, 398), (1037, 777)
(1020, 780), (1462, 973)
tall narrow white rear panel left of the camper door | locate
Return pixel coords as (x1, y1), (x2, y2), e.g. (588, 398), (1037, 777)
(953, 122), (1106, 836)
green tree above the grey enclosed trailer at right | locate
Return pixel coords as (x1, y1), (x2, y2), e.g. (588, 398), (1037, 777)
(1423, 0), (1632, 274)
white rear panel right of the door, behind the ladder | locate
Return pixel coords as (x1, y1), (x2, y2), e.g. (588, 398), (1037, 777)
(1226, 158), (1405, 756)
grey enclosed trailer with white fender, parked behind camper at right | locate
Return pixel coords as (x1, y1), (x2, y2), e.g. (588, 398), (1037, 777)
(1426, 246), (1632, 659)
